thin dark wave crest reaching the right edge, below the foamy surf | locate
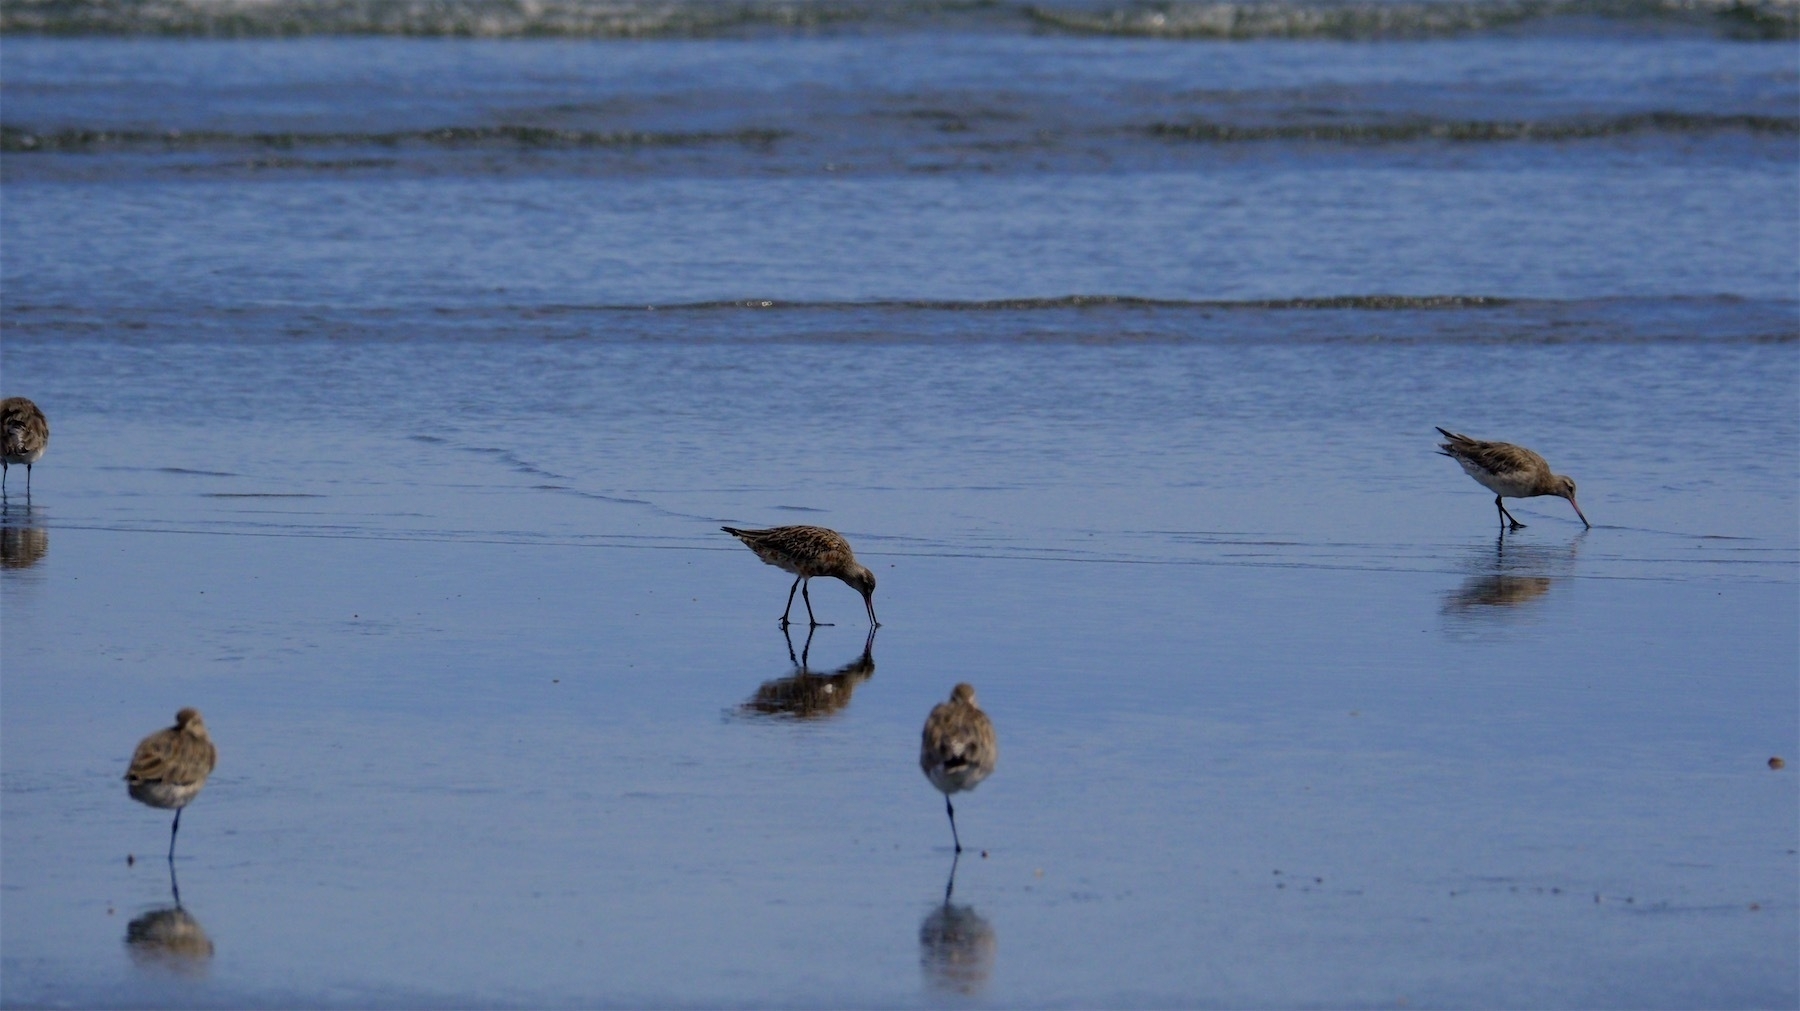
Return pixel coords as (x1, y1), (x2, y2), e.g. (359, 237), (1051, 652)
(1145, 112), (1800, 144)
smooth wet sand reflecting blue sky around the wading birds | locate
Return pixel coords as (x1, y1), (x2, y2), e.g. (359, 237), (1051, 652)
(0, 383), (1800, 1007)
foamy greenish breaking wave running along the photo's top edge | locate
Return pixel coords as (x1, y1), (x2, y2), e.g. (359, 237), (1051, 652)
(0, 0), (1800, 40)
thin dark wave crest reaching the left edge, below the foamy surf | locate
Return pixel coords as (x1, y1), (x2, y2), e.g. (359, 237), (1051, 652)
(0, 126), (787, 153)
